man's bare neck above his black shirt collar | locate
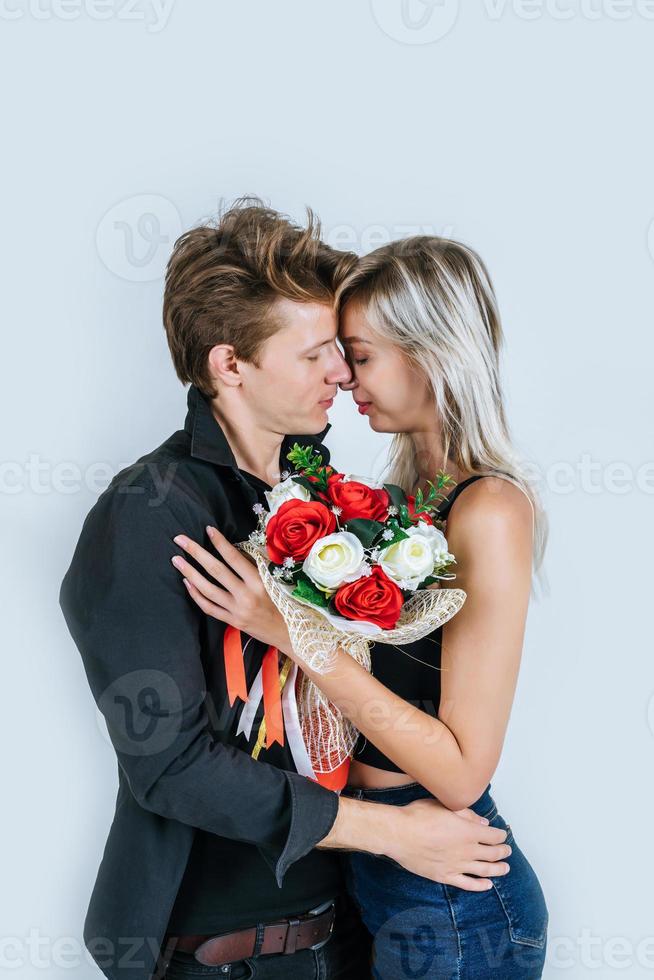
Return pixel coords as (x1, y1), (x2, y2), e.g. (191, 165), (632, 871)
(211, 398), (284, 486)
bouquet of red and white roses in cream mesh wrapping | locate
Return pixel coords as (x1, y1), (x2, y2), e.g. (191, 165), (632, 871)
(238, 444), (466, 788)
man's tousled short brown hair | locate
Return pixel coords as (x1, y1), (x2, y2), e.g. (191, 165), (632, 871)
(163, 197), (357, 398)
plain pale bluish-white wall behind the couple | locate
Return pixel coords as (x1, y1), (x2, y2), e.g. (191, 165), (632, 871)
(0, 0), (654, 980)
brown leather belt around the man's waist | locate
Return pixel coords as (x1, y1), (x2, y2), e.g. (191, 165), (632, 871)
(164, 899), (336, 966)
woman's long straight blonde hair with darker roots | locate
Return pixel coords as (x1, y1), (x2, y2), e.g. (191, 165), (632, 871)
(336, 235), (548, 588)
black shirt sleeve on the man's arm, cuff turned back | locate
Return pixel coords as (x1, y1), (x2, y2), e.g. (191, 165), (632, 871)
(59, 476), (339, 888)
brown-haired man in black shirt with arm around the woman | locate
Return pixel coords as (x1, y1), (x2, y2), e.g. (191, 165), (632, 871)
(60, 201), (505, 980)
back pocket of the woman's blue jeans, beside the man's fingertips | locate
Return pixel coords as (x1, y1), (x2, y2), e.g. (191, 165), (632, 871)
(490, 813), (549, 949)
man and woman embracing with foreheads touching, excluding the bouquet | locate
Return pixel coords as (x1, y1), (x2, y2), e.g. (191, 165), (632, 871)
(60, 199), (548, 980)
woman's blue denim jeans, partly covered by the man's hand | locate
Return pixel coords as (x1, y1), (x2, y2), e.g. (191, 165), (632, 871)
(342, 783), (549, 980)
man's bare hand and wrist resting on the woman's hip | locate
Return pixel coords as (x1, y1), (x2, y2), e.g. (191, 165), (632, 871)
(317, 797), (511, 891)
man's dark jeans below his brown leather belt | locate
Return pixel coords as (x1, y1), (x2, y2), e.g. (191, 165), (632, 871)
(164, 892), (372, 980)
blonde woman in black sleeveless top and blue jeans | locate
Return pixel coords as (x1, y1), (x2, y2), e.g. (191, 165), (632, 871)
(173, 236), (548, 980)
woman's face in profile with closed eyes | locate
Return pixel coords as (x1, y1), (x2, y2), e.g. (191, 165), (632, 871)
(339, 299), (435, 433)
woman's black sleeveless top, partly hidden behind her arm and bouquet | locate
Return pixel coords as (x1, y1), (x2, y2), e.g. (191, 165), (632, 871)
(353, 470), (511, 772)
